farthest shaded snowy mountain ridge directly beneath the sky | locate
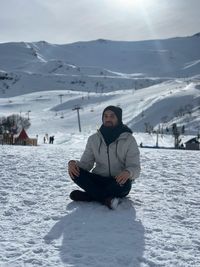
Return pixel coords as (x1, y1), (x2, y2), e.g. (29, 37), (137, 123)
(0, 34), (200, 77)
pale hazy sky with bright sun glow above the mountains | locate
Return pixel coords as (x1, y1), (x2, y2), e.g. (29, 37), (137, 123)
(0, 0), (200, 44)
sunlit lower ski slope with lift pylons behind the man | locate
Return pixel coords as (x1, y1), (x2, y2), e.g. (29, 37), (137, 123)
(0, 79), (200, 138)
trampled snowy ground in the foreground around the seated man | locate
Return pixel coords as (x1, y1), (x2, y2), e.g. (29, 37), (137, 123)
(0, 140), (200, 267)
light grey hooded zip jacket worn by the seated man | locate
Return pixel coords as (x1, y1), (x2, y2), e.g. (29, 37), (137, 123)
(77, 131), (140, 180)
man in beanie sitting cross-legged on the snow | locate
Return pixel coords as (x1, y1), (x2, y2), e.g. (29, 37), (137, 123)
(68, 106), (140, 209)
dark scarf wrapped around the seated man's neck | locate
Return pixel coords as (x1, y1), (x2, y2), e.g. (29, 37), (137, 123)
(99, 124), (132, 146)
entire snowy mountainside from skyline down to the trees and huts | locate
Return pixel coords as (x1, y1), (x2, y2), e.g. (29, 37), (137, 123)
(0, 35), (200, 137)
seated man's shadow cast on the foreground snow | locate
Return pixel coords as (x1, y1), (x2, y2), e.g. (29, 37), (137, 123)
(44, 198), (145, 267)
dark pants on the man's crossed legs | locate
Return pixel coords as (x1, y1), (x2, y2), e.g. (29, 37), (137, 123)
(73, 168), (132, 201)
